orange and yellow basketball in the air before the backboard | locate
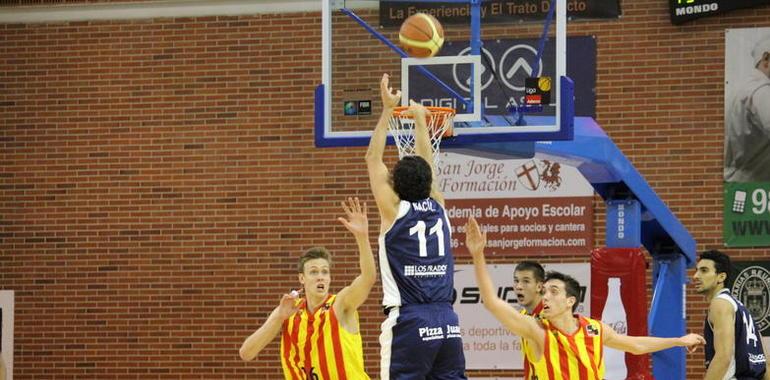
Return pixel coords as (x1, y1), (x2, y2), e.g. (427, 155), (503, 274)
(398, 13), (444, 58)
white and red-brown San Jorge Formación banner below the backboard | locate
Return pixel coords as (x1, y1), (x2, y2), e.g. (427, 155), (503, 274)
(437, 152), (593, 257)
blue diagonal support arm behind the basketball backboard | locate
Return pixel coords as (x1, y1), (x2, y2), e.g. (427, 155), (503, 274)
(535, 117), (696, 266)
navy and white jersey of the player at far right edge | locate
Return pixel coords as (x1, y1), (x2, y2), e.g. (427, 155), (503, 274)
(703, 289), (767, 379)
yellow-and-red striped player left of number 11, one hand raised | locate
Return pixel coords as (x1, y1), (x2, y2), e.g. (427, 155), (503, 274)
(240, 198), (377, 380)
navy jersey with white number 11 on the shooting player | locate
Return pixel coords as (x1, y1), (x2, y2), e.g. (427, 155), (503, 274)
(379, 198), (454, 307)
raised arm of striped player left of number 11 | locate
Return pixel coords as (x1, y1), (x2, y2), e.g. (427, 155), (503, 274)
(335, 198), (377, 313)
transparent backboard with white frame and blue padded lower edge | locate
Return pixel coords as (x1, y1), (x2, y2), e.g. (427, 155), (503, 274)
(315, 0), (574, 146)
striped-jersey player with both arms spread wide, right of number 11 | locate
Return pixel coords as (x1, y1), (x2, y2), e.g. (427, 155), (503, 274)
(465, 218), (705, 380)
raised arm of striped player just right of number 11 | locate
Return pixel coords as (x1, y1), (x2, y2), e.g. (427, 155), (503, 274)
(465, 218), (544, 347)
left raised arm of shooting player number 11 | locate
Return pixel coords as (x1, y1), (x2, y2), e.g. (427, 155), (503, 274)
(366, 74), (401, 224)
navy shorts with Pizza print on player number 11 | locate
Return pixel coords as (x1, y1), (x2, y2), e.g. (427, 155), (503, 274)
(380, 303), (467, 380)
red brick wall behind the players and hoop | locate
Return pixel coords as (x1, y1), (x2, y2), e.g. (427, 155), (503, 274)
(0, 0), (770, 379)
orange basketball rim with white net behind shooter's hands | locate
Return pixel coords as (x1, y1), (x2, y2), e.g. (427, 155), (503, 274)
(388, 107), (455, 167)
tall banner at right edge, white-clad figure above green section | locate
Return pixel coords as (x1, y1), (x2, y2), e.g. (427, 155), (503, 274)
(722, 28), (770, 247)
